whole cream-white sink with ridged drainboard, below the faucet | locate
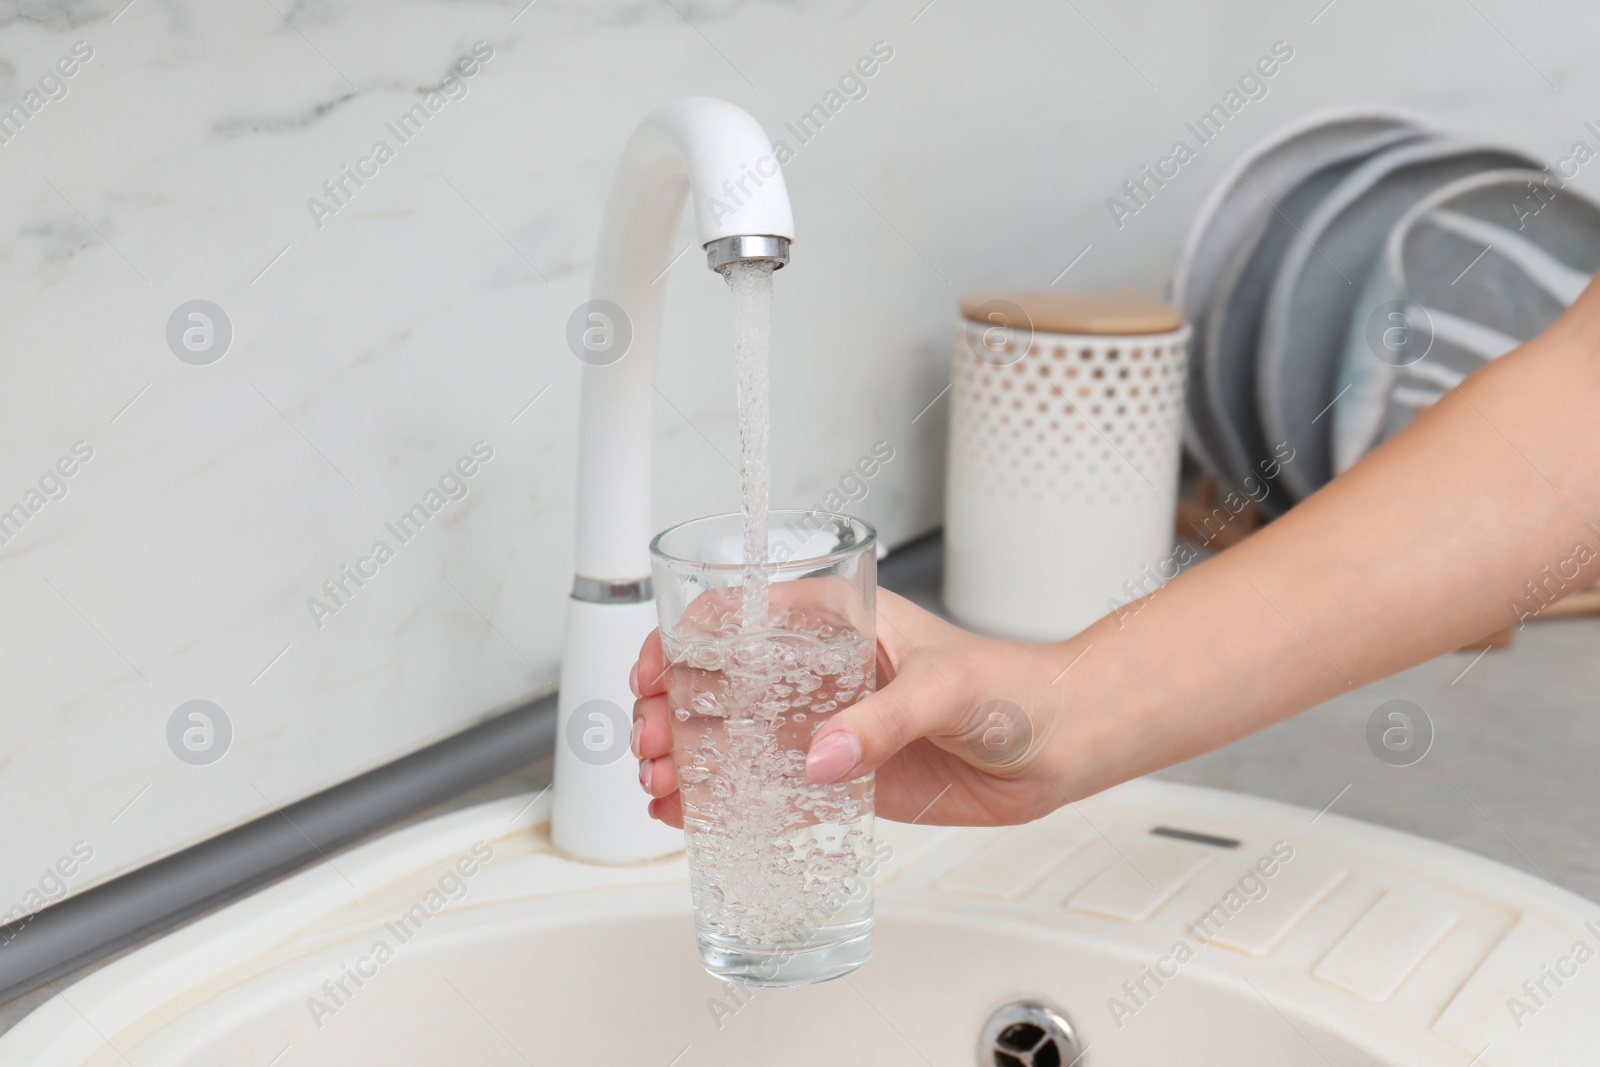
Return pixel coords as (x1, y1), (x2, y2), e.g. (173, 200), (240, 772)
(0, 781), (1600, 1067)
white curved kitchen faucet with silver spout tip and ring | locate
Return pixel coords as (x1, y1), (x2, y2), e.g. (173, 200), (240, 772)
(550, 96), (794, 864)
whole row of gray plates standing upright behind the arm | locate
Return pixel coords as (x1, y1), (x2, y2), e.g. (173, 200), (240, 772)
(1173, 109), (1600, 514)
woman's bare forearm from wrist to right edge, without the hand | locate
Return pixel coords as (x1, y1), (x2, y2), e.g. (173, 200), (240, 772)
(1042, 279), (1600, 795)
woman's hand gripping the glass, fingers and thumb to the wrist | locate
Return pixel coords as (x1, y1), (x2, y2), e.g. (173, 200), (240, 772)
(629, 590), (1070, 825)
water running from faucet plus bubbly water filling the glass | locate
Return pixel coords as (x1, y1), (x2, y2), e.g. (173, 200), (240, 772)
(661, 262), (877, 985)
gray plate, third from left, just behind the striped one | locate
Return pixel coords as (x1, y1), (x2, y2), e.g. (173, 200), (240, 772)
(1256, 136), (1538, 499)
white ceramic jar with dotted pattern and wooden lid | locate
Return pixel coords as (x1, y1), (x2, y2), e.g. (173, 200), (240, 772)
(944, 293), (1189, 641)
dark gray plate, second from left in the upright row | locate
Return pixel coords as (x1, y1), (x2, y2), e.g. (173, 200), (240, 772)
(1200, 128), (1421, 515)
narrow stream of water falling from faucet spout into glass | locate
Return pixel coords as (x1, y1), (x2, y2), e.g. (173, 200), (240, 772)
(723, 259), (773, 632)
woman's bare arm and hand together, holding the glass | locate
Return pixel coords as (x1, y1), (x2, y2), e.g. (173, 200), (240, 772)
(634, 282), (1600, 825)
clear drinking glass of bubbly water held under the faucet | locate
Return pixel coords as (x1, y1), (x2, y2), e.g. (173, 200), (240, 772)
(650, 510), (880, 985)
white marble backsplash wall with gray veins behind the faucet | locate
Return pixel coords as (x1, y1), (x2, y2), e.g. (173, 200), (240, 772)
(0, 0), (1600, 910)
